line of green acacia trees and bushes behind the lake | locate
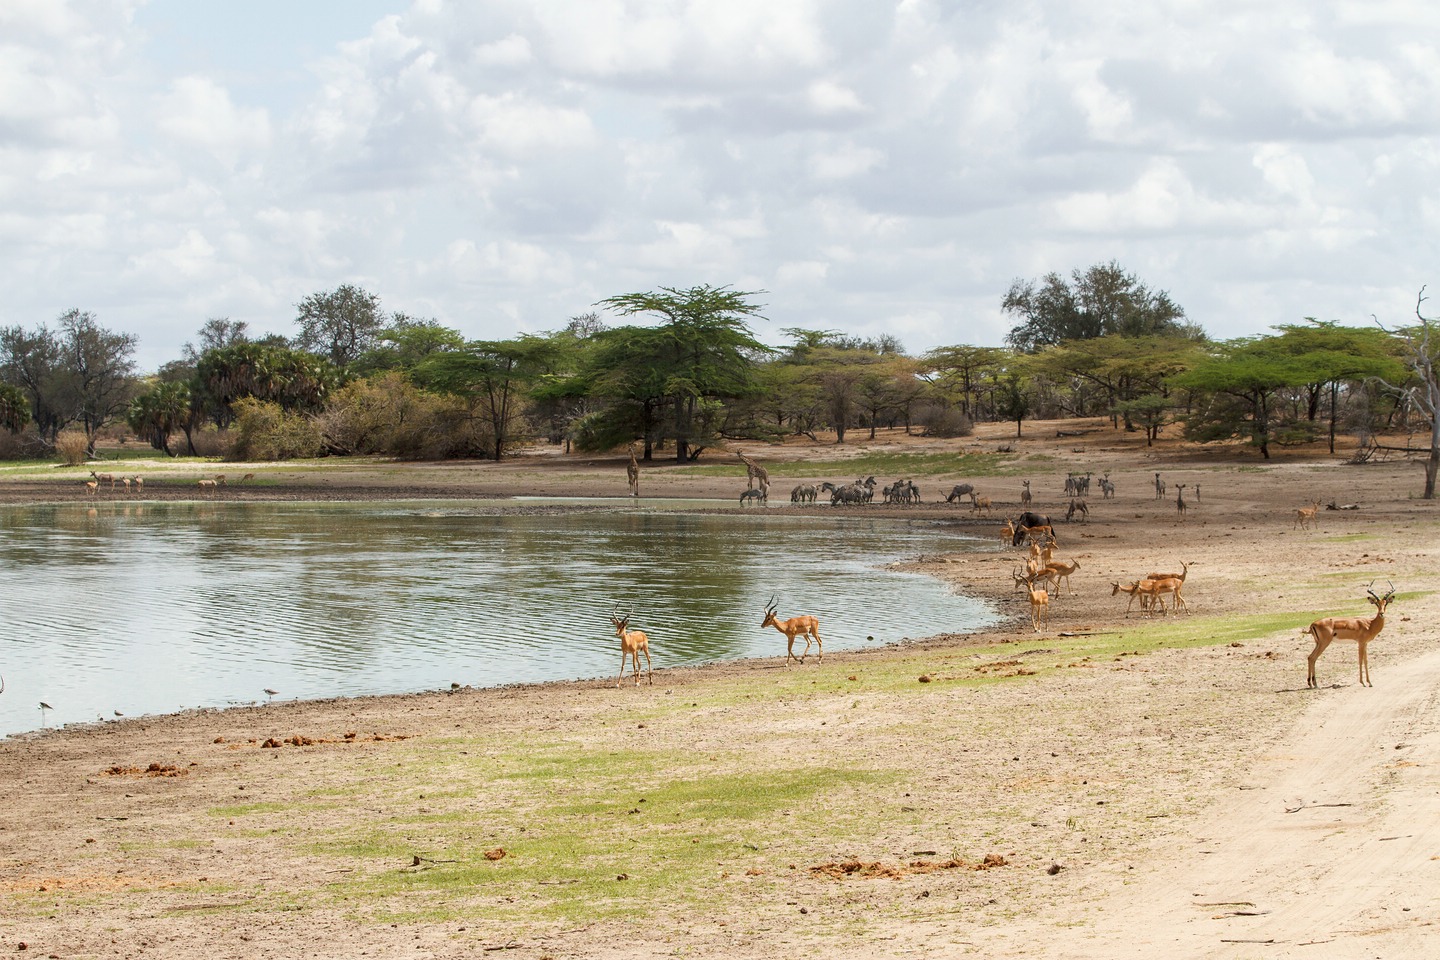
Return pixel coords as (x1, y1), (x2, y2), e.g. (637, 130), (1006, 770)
(0, 262), (1440, 495)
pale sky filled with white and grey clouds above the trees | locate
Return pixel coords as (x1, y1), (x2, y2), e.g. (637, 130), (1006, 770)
(0, 0), (1440, 370)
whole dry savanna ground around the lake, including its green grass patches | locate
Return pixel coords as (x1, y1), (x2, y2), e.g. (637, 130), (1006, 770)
(0, 420), (1440, 960)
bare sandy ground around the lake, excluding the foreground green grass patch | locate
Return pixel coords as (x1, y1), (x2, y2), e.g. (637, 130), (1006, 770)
(0, 425), (1440, 960)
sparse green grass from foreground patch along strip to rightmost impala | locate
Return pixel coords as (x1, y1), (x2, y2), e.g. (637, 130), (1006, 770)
(244, 612), (1320, 924)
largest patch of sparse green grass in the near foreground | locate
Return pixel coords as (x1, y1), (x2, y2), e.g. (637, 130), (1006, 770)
(311, 743), (899, 923)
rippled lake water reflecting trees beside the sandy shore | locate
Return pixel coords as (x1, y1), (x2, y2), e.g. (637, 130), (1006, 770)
(0, 501), (998, 734)
